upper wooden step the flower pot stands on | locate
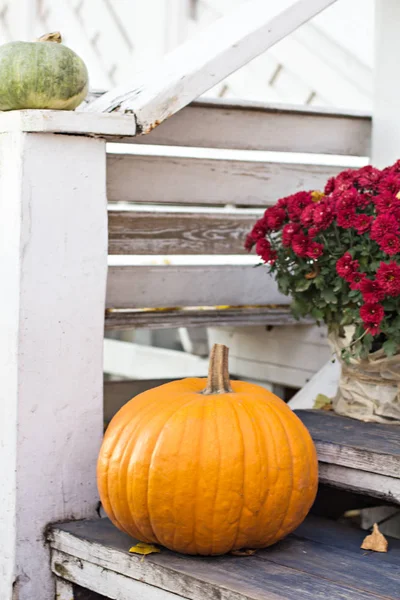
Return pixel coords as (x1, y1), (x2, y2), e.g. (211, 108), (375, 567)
(295, 410), (400, 503)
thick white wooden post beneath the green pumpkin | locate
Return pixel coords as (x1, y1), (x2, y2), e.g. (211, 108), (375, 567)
(0, 127), (107, 600)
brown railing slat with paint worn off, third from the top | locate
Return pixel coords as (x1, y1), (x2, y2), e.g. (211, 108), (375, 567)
(108, 210), (258, 254)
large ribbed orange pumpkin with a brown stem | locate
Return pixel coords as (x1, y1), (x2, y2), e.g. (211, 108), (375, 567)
(97, 344), (318, 555)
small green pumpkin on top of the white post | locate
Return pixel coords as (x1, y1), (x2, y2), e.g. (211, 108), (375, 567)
(0, 33), (89, 110)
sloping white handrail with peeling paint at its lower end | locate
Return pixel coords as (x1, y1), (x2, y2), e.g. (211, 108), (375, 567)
(84, 0), (335, 133)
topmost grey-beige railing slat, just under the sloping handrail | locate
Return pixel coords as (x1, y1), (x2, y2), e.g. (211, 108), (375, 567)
(134, 100), (371, 156)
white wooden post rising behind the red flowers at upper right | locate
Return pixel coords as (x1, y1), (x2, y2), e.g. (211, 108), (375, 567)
(372, 0), (400, 167)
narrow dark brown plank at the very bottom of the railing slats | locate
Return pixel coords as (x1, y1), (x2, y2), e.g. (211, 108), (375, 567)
(105, 306), (313, 330)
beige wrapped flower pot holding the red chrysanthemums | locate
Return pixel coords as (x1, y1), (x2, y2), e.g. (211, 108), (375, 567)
(328, 327), (400, 424)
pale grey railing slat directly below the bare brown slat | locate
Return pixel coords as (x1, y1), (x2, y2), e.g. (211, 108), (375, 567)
(106, 265), (290, 308)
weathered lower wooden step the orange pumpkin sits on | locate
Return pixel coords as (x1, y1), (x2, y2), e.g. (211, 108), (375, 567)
(49, 516), (400, 600)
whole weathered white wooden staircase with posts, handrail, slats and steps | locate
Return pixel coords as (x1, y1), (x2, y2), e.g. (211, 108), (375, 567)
(0, 0), (400, 600)
